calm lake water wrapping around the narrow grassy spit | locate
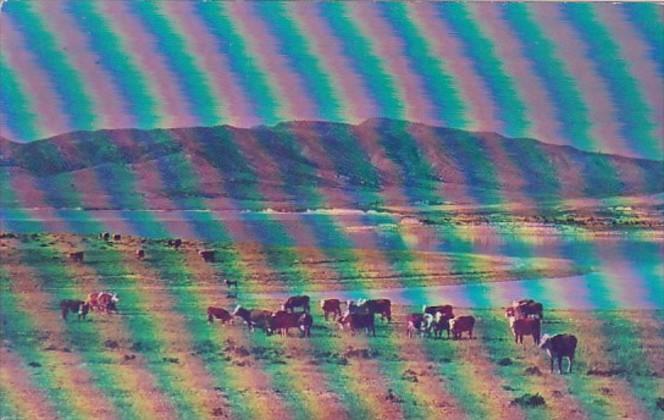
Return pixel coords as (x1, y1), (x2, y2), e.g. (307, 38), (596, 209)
(0, 210), (664, 309)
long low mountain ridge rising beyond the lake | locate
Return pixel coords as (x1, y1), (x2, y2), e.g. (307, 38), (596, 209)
(0, 119), (664, 208)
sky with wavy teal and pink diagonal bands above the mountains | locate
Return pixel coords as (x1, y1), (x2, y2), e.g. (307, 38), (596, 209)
(0, 0), (664, 159)
